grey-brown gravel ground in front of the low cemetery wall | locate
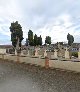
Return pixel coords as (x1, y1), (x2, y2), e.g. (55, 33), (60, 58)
(0, 60), (80, 92)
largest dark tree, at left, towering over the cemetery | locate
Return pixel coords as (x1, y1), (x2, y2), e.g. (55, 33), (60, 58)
(10, 21), (23, 52)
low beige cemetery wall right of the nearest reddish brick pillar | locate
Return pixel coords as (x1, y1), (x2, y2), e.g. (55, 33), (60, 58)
(49, 60), (80, 72)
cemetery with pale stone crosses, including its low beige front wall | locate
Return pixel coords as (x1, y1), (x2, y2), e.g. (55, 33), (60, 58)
(0, 46), (80, 72)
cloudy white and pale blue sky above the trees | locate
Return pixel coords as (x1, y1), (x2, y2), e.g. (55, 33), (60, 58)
(0, 0), (80, 44)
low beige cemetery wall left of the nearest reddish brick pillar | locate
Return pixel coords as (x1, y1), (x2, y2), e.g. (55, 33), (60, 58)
(0, 54), (45, 67)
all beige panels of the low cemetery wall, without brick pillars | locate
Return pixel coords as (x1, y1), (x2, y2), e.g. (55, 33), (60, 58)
(0, 55), (80, 72)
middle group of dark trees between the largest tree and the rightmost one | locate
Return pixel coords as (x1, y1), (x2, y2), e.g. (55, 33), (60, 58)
(26, 30), (51, 46)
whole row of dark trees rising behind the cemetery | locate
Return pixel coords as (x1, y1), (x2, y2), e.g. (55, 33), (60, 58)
(10, 21), (74, 51)
